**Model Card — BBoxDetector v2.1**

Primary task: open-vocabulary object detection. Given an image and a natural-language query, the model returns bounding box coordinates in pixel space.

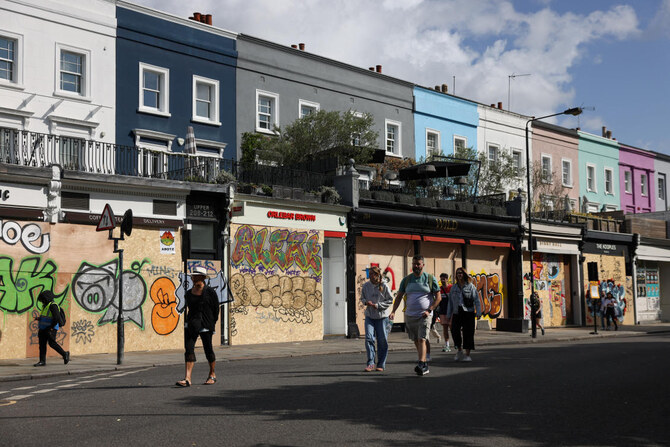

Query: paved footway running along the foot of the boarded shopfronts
[0,323,670,382]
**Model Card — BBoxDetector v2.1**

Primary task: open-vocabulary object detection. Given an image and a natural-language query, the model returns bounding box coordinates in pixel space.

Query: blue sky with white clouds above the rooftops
[131,0,670,154]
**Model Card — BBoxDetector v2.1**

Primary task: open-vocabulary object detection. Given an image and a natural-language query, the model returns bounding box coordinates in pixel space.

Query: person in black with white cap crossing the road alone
[177,267,219,386]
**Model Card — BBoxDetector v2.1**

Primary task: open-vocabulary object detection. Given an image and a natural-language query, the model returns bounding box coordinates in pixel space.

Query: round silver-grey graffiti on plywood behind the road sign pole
[72,259,148,329]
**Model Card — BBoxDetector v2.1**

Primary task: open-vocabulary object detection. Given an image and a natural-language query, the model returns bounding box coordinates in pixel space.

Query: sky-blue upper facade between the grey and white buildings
[414,86,479,160]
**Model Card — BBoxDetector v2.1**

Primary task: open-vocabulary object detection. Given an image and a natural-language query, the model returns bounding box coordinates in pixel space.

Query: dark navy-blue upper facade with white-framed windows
[116,1,237,176]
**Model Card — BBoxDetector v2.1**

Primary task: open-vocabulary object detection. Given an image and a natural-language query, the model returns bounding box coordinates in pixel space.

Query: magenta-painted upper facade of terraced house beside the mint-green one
[619,144,656,213]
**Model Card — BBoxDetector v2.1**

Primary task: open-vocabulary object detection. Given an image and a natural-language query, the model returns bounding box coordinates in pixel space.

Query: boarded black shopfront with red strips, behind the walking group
[350,207,518,330]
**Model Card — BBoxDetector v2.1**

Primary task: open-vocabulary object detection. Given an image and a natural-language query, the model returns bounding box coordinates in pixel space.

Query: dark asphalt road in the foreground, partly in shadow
[0,334,670,447]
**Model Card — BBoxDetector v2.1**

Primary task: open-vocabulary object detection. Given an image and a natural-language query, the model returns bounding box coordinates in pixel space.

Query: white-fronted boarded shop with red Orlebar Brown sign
[229,195,349,345]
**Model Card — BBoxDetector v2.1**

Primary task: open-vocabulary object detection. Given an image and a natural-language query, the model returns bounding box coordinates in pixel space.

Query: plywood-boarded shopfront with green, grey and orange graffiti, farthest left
[0,220,183,359]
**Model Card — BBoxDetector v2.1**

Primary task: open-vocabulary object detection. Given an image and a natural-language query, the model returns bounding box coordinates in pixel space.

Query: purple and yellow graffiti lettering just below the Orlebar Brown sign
[231,225,323,277]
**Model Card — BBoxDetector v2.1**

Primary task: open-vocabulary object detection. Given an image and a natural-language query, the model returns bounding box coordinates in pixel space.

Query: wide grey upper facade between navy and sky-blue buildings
[236,34,414,158]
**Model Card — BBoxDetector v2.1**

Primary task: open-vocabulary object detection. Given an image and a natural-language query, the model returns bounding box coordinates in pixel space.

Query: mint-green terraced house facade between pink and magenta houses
[579,131,621,213]
